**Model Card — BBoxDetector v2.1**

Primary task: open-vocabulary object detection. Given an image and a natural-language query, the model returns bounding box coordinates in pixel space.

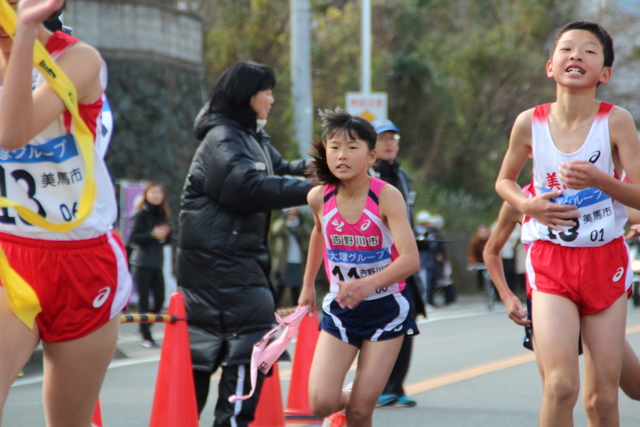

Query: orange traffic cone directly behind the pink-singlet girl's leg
[284,311,322,424]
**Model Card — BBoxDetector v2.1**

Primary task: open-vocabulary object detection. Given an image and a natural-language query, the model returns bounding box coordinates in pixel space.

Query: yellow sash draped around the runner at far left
[0,0,96,329]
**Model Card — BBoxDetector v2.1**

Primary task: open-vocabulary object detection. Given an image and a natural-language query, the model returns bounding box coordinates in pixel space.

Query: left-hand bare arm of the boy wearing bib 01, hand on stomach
[496,110,579,231]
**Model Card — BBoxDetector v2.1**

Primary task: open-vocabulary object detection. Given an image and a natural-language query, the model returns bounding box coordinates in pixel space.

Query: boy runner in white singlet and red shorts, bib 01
[496,21,640,427]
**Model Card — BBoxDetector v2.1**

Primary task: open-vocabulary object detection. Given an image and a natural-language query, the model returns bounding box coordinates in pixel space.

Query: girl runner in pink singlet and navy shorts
[298,110,420,427]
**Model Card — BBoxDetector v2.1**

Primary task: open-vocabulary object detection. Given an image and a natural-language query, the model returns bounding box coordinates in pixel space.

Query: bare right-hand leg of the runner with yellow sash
[42,316,120,427]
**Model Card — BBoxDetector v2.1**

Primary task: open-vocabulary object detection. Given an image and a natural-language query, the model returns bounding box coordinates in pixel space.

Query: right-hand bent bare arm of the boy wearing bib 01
[560,107,640,209]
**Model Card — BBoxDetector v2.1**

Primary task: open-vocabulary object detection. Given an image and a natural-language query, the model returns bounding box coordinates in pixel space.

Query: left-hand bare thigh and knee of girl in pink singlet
[309,331,358,417]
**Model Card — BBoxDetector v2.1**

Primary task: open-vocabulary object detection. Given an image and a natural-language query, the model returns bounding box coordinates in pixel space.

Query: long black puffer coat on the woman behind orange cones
[177,113,311,372]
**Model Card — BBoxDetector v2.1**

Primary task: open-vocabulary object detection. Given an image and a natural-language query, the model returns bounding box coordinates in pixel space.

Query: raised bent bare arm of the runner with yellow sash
[0,0,102,150]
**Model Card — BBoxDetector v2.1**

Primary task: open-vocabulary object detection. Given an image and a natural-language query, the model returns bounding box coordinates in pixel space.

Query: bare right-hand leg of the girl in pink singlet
[347,336,404,427]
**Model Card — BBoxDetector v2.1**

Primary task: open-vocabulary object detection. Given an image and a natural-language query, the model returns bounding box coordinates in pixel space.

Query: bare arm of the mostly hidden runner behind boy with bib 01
[483,202,531,326]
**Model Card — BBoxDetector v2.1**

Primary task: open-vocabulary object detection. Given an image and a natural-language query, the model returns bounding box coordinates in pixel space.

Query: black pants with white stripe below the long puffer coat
[193,365,265,427]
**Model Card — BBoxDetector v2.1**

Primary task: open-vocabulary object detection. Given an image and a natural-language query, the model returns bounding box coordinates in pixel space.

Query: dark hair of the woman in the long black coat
[209,61,276,129]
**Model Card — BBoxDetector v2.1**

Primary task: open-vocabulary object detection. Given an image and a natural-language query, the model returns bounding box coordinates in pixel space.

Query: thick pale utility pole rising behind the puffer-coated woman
[290,0,313,157]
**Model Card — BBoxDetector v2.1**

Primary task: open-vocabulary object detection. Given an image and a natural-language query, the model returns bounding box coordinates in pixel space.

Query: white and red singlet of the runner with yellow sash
[0,31,117,240]
